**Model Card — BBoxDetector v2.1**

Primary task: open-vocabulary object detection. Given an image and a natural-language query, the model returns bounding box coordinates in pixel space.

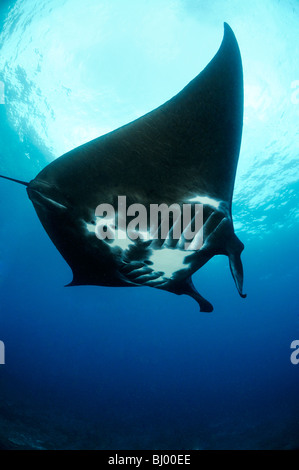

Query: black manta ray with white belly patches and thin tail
[2,23,245,312]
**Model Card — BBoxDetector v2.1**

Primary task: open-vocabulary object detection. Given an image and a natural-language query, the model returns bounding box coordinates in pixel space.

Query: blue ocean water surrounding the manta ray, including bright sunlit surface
[0,0,299,449]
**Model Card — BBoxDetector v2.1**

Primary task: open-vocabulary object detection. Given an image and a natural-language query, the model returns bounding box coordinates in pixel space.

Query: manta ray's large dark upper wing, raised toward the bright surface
[38,24,243,209]
